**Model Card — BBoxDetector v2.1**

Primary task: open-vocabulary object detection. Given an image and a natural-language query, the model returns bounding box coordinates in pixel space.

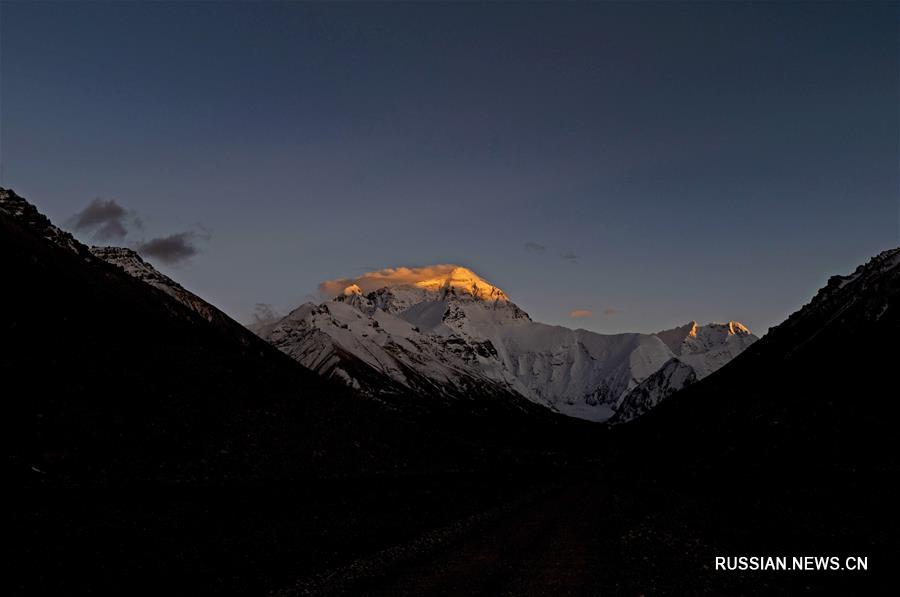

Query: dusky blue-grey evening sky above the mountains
[0,1,900,333]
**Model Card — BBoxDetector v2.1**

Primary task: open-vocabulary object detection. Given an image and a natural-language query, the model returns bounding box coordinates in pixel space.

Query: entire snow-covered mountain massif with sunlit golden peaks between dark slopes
[251,265,756,421]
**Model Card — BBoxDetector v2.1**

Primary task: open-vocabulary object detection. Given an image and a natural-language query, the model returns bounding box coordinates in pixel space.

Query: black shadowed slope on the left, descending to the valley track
[0,190,592,595]
